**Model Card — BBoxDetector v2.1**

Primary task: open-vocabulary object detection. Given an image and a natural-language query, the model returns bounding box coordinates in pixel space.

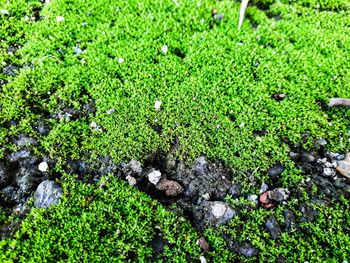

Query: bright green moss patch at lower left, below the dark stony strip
[0,176,199,262]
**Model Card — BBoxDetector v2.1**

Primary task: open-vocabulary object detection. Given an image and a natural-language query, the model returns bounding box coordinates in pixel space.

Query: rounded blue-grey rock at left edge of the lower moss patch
[34,180,62,208]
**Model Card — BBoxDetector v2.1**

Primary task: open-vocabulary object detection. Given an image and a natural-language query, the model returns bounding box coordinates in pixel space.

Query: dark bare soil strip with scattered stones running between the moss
[0,131,350,257]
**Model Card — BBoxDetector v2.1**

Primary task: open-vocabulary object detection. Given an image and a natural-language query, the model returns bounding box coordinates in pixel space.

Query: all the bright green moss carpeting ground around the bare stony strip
[0,0,350,262]
